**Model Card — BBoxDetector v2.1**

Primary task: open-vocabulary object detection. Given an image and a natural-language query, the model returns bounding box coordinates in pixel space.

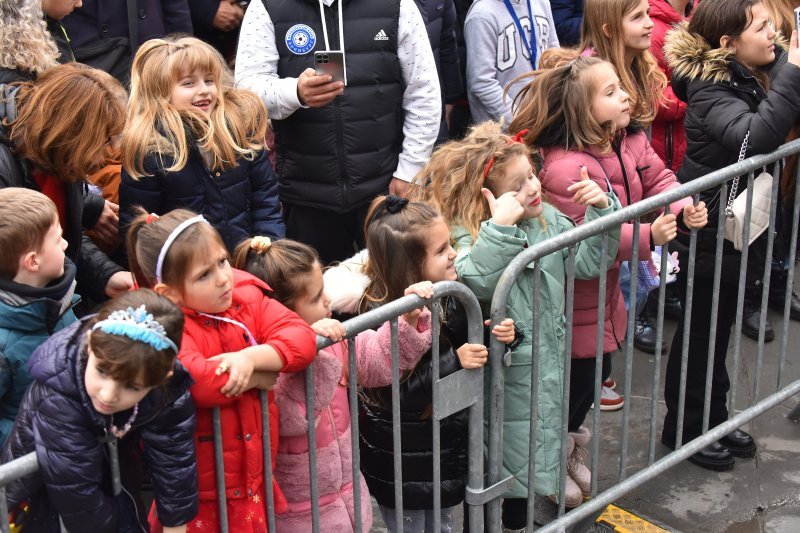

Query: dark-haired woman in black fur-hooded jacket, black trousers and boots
[661,0,800,470]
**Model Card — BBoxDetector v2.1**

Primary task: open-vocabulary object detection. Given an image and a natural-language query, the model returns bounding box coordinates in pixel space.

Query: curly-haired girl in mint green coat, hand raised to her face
[421,122,619,529]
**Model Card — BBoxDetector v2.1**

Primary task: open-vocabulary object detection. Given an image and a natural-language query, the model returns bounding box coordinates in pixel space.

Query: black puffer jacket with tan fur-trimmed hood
[664,23,800,284]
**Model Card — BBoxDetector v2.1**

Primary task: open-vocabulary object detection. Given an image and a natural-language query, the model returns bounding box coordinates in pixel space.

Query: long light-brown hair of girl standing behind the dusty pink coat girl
[540,0,668,127]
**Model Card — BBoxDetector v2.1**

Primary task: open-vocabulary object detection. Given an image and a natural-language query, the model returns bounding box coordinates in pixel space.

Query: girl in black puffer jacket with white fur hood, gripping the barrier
[325,195,514,532]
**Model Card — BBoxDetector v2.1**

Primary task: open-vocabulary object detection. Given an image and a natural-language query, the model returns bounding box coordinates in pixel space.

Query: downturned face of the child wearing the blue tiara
[84,344,153,415]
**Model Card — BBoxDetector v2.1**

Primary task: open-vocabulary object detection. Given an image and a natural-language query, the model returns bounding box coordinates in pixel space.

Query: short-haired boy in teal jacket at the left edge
[0,187,78,446]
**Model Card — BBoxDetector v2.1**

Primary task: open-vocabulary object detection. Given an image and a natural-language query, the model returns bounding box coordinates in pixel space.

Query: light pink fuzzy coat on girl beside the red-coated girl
[275,310,431,533]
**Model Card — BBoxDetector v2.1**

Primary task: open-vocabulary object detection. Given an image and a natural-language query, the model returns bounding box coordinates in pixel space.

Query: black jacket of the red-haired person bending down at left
[0,85,123,301]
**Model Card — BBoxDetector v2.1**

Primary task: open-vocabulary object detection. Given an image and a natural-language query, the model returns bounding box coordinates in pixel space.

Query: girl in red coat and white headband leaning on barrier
[128,209,316,533]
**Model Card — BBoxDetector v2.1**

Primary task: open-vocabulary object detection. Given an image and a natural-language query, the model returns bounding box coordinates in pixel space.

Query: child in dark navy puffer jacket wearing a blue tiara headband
[3,289,198,533]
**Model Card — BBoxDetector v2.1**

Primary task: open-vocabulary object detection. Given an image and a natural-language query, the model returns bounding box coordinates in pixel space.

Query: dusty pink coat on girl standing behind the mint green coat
[539,131,692,359]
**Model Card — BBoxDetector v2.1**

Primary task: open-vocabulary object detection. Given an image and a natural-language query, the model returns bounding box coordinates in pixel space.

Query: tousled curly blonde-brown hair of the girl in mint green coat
[412,120,530,239]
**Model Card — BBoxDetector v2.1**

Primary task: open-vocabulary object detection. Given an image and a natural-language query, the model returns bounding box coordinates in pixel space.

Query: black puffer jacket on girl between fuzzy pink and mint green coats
[358,298,468,509]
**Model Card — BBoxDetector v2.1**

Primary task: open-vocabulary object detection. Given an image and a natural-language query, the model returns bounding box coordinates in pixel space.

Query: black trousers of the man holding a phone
[283,202,369,265]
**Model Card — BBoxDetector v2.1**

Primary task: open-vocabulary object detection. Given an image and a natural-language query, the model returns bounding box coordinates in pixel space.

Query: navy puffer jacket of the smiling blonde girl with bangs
[119,143,286,252]
